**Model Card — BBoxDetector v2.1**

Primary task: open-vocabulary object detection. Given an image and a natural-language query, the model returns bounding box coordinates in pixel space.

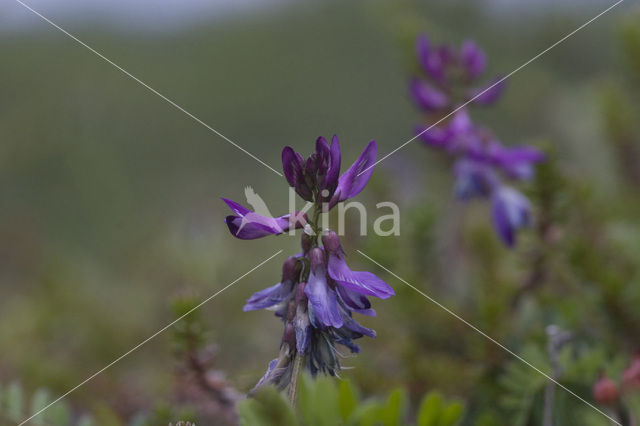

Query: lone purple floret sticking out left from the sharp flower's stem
[222,198,306,240]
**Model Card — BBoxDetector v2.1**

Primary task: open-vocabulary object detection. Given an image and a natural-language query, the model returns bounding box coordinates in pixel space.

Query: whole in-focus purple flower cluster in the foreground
[223,136,394,389]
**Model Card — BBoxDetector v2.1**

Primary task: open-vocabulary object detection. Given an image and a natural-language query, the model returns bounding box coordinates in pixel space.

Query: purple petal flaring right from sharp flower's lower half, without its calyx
[329,253,395,299]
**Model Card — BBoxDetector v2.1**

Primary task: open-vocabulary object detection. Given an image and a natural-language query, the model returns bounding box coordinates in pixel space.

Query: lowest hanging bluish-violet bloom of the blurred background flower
[491,186,531,247]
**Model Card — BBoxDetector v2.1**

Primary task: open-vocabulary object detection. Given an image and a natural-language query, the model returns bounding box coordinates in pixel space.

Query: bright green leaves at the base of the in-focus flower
[238,376,463,426]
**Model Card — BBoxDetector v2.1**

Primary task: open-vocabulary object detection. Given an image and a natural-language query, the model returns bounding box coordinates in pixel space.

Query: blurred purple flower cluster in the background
[409,36,544,247]
